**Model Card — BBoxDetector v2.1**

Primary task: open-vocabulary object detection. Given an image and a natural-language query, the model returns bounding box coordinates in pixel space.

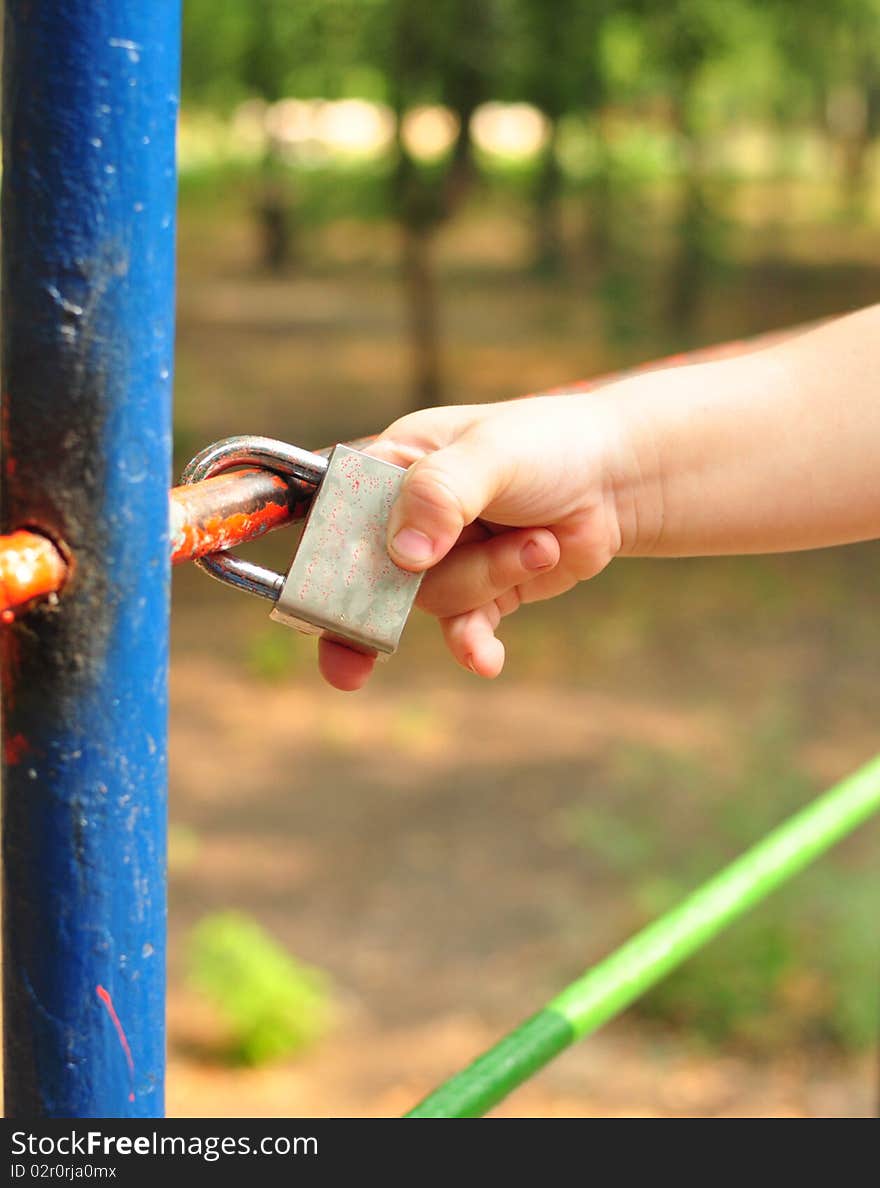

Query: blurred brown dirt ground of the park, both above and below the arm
[162,194,880,1116]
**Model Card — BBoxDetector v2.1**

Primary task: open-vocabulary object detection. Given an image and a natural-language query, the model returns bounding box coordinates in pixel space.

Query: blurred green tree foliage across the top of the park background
[176,0,880,311]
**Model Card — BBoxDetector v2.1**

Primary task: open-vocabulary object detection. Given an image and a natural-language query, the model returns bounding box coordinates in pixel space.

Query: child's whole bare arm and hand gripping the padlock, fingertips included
[319,305,880,690]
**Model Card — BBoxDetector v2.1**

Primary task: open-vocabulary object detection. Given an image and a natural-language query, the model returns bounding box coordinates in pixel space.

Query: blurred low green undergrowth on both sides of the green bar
[561,709,880,1051]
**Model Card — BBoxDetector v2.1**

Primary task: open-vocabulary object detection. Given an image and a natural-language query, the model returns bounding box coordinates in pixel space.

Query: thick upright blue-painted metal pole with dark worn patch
[0,0,179,1118]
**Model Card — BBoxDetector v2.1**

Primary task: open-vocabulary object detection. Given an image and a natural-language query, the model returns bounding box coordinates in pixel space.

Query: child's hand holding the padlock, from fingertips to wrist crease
[319,394,621,689]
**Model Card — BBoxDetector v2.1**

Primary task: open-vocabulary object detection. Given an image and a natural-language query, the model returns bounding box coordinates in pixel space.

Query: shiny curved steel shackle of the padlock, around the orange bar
[181,435,328,602]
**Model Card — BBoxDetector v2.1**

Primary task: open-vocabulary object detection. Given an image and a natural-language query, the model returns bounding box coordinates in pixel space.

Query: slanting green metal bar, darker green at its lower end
[407,756,880,1118]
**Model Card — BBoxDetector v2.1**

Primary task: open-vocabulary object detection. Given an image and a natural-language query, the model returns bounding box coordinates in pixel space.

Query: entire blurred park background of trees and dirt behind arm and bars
[169,0,880,1116]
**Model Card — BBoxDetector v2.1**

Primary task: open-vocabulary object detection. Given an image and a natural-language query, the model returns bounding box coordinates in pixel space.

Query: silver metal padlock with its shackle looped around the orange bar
[182,437,422,658]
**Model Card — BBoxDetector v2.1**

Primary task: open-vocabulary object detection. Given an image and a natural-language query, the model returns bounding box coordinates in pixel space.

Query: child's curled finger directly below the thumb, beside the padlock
[418,529,559,619]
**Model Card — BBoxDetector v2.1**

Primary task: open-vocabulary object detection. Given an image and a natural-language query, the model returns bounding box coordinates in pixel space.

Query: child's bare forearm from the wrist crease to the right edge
[600,307,880,556]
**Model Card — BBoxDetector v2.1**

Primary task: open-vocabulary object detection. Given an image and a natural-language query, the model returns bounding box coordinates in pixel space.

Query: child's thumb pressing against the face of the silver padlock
[388,432,507,570]
